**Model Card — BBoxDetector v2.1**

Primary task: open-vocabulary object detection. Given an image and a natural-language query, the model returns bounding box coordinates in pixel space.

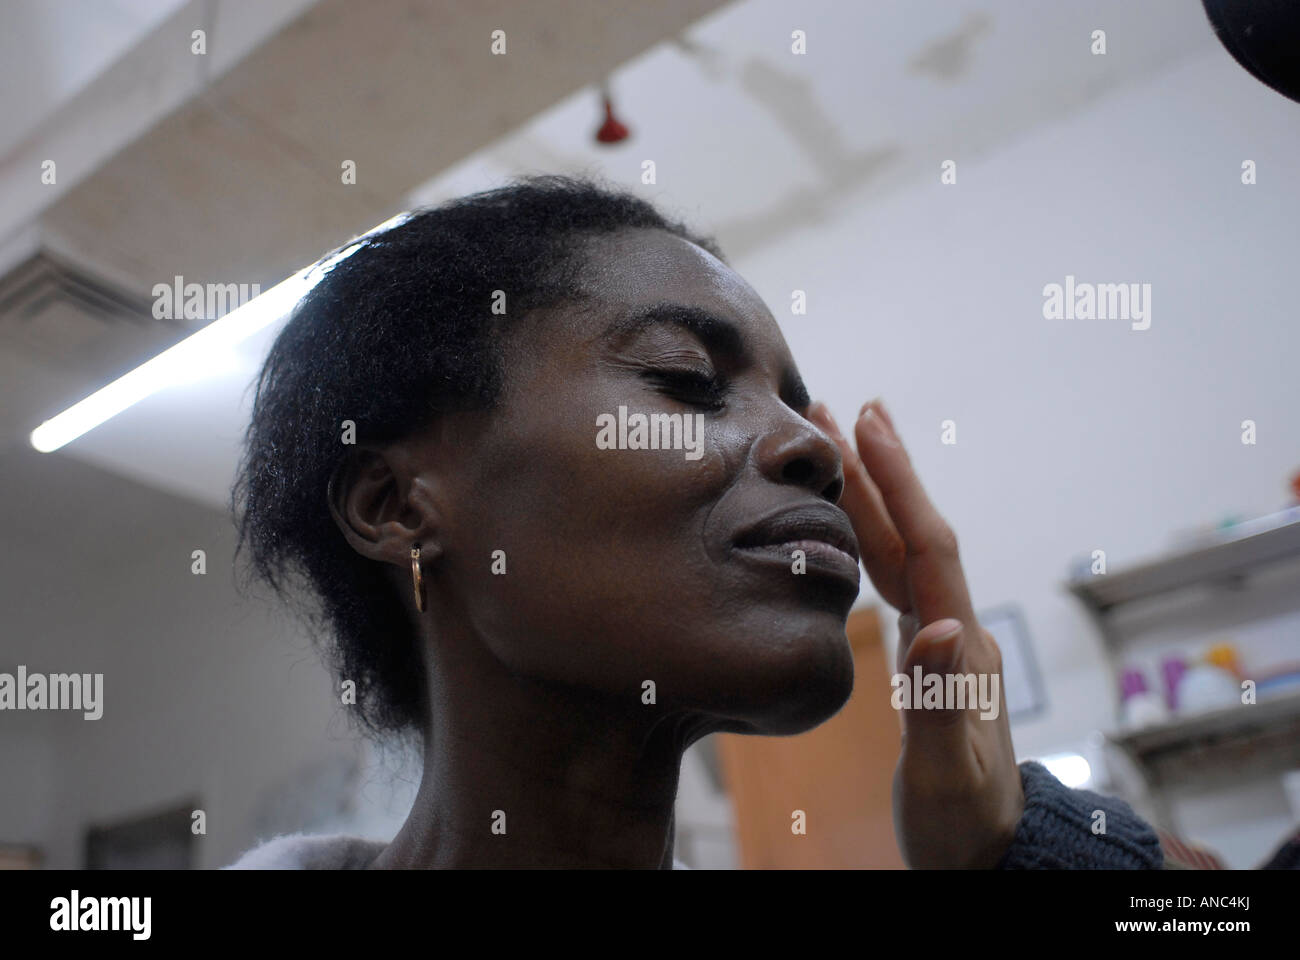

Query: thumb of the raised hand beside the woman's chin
[893,619,966,762]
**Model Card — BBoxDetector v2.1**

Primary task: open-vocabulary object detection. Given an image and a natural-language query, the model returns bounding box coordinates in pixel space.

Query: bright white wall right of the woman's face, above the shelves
[738,44,1300,866]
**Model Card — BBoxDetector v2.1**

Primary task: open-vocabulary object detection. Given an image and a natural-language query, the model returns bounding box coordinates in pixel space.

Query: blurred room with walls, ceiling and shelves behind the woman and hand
[0,0,1300,869]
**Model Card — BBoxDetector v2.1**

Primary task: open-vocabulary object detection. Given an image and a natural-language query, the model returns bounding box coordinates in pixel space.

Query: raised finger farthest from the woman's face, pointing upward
[854,401,975,624]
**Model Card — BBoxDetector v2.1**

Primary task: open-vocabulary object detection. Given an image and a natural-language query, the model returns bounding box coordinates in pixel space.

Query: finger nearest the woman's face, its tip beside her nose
[809,403,910,610]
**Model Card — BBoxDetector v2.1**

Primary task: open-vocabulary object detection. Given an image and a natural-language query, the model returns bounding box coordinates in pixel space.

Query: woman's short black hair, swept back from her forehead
[231,176,720,738]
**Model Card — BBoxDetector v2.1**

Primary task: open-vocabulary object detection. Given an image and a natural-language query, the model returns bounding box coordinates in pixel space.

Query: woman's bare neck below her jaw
[373,613,707,869]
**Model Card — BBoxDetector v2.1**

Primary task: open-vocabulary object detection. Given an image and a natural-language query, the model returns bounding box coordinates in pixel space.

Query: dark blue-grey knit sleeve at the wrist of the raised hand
[997,760,1164,870]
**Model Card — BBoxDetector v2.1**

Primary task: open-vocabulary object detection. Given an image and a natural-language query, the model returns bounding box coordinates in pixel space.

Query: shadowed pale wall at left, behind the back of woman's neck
[0,454,412,868]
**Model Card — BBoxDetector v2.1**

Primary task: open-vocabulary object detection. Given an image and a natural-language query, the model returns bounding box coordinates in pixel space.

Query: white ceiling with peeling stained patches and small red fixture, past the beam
[17,0,1217,506]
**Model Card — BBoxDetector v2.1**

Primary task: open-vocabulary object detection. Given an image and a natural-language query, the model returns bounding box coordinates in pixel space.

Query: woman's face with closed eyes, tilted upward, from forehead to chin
[421,230,858,734]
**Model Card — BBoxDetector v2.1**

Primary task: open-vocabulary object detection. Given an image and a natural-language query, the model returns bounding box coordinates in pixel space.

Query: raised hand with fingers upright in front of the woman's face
[809,401,1024,868]
